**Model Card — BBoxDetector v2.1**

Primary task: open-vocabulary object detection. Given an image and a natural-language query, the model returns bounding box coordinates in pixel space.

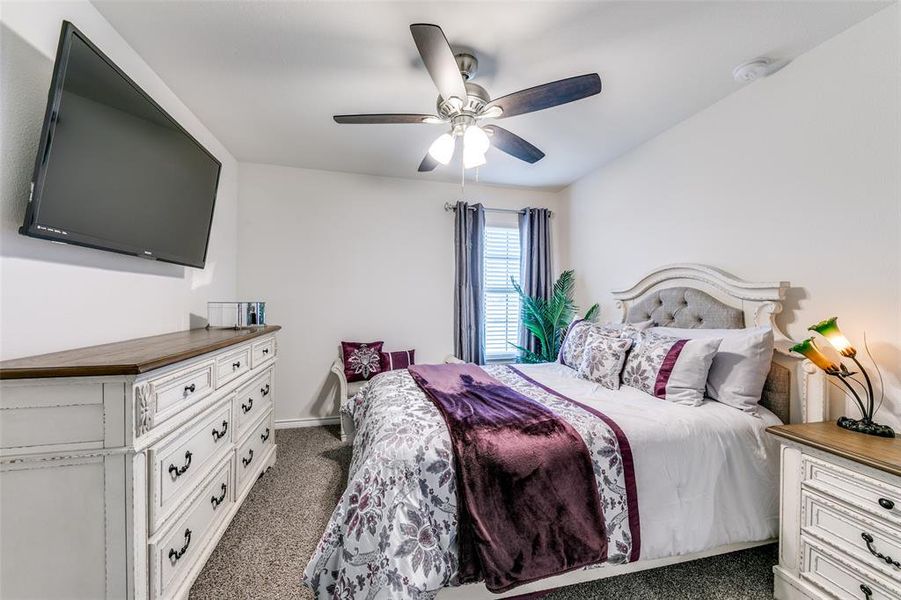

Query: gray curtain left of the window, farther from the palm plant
[454,202,485,365]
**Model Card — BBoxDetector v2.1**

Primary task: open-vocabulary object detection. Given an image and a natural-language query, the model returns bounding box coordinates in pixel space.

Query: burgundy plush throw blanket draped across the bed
[409,364,607,592]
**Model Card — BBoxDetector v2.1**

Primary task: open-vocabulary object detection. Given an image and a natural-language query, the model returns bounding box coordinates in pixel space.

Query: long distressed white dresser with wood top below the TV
[0,326,279,600]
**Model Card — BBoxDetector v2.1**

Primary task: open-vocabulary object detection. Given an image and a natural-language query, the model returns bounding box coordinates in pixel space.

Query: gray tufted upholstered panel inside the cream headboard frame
[625,278,791,423]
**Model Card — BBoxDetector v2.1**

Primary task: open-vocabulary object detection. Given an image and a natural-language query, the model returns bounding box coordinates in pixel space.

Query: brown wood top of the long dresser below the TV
[0,325,281,379]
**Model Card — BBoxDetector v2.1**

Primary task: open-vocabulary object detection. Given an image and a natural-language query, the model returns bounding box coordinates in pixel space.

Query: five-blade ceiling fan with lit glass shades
[334,23,601,172]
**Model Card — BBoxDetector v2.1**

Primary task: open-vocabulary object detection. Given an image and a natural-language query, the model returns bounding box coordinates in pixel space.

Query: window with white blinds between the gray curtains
[484,225,520,361]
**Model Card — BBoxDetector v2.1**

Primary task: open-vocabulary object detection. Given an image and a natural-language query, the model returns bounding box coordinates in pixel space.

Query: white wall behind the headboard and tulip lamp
[561,5,901,426]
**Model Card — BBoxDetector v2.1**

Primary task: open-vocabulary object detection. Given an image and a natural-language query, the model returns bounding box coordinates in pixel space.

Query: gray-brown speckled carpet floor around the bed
[190,427,777,600]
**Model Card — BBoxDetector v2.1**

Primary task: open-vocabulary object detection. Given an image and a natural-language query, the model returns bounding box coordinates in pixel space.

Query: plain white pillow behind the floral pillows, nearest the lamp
[648,326,773,414]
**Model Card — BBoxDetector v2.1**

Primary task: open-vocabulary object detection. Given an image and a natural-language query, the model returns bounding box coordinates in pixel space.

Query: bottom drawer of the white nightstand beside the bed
[801,540,901,600]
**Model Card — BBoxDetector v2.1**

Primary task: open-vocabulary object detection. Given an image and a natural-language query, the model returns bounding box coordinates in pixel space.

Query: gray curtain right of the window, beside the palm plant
[519,208,554,352]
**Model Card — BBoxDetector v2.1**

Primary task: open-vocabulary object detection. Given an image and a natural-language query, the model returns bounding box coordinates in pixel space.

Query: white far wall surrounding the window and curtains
[238,163,560,421]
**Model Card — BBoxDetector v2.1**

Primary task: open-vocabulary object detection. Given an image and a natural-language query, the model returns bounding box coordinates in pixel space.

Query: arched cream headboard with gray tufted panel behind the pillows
[613,264,826,423]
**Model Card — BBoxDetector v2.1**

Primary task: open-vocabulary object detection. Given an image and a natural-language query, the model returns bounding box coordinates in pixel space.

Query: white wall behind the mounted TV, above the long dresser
[0,1,237,359]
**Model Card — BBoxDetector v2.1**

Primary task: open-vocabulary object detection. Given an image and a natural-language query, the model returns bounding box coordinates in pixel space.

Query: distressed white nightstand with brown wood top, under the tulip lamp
[767,423,901,600]
